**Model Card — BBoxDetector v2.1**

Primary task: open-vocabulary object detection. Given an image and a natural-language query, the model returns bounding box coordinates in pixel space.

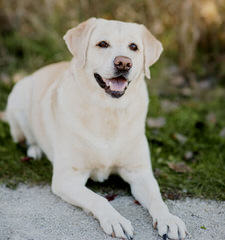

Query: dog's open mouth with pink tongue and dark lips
[94,73,129,98]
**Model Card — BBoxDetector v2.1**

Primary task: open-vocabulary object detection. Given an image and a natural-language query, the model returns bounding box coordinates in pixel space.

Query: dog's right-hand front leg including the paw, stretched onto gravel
[120,167,186,240]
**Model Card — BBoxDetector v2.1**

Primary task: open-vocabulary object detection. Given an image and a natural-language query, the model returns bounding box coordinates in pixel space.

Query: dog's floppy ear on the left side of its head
[63,18,96,68]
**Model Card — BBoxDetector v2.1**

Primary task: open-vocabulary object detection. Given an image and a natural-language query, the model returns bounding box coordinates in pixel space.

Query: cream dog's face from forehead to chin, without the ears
[87,20,144,98]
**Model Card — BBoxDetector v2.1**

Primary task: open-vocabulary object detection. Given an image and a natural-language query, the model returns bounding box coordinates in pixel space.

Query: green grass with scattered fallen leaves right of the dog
[147,94,225,200]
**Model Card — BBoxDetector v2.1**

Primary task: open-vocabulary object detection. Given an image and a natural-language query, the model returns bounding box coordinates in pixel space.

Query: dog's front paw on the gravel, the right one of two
[153,214,187,240]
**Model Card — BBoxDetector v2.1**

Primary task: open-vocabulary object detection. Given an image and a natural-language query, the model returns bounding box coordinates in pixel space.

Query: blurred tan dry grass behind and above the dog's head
[0,0,225,75]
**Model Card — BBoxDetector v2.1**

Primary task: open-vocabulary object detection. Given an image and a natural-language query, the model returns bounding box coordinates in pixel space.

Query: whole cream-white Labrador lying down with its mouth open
[5,18,186,239]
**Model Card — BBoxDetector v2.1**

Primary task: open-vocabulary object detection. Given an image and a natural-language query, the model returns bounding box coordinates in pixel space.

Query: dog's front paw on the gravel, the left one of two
[100,214,134,240]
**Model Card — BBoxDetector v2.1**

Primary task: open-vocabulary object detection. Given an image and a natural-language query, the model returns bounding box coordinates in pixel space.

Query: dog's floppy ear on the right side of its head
[142,25,163,79]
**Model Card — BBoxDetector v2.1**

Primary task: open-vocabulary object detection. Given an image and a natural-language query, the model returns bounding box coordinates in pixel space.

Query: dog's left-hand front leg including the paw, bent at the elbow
[52,165,133,240]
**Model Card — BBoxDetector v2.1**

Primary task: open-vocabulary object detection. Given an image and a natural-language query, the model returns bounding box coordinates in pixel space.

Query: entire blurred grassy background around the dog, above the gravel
[0,0,225,199]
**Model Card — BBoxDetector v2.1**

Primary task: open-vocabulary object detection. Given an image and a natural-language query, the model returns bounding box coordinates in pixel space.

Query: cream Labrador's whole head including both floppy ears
[64,18,163,98]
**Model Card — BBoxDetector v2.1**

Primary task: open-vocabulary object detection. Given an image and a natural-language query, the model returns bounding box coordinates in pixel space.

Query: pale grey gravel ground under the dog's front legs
[0,185,225,240]
